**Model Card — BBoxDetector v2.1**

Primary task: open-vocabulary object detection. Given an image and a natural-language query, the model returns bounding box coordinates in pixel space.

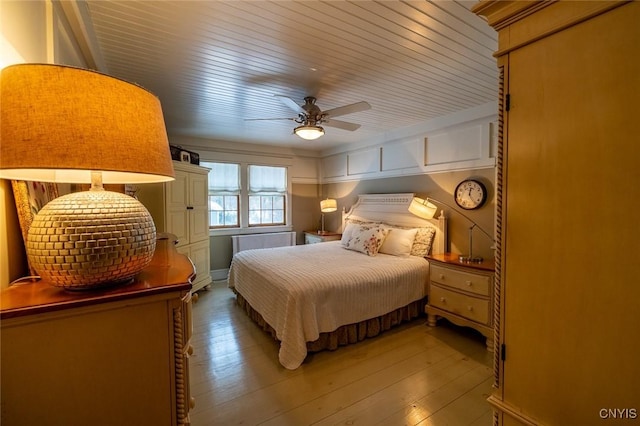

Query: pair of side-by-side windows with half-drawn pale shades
[202,162,288,229]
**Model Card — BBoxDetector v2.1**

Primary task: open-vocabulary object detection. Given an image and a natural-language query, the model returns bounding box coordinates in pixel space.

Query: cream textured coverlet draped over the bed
[229,241,429,369]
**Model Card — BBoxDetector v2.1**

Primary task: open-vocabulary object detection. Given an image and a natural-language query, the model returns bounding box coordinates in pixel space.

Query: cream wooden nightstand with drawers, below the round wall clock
[425,253,495,351]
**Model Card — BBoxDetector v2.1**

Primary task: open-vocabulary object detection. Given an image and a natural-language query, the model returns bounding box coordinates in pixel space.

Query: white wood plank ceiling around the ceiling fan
[86,0,497,149]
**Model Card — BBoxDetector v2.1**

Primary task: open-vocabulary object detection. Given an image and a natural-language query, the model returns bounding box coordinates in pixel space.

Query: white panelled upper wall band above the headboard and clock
[320,102,498,183]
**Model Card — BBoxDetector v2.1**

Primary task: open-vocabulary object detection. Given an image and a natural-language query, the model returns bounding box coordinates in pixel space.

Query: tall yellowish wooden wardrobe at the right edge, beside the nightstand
[473,1,640,426]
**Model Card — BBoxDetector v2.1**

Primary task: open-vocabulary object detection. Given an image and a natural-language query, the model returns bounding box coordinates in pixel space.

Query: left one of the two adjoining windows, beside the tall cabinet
[208,163,240,228]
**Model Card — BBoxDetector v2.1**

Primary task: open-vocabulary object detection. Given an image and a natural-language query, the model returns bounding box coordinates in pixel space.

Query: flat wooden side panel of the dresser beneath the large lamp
[0,298,175,426]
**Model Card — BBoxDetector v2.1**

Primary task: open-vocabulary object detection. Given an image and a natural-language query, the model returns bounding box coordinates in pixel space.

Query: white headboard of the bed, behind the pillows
[342,193,447,254]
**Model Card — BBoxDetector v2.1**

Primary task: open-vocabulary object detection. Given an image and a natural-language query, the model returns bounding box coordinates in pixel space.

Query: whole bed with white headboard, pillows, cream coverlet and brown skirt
[229,193,446,370]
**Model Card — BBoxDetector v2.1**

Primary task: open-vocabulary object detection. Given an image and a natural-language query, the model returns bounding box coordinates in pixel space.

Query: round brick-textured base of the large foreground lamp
[27,190,156,290]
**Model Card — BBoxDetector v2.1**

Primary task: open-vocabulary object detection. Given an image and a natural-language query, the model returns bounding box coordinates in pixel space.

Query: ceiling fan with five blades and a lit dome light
[248,95,371,140]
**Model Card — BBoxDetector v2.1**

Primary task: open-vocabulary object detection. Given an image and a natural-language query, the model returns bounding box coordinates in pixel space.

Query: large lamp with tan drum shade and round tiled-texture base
[0,64,174,290]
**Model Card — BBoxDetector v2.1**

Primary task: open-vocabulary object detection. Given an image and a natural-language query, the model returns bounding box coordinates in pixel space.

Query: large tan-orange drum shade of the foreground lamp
[0,64,174,184]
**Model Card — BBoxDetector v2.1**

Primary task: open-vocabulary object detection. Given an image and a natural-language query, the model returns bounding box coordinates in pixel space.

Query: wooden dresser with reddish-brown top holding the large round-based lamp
[0,239,194,426]
